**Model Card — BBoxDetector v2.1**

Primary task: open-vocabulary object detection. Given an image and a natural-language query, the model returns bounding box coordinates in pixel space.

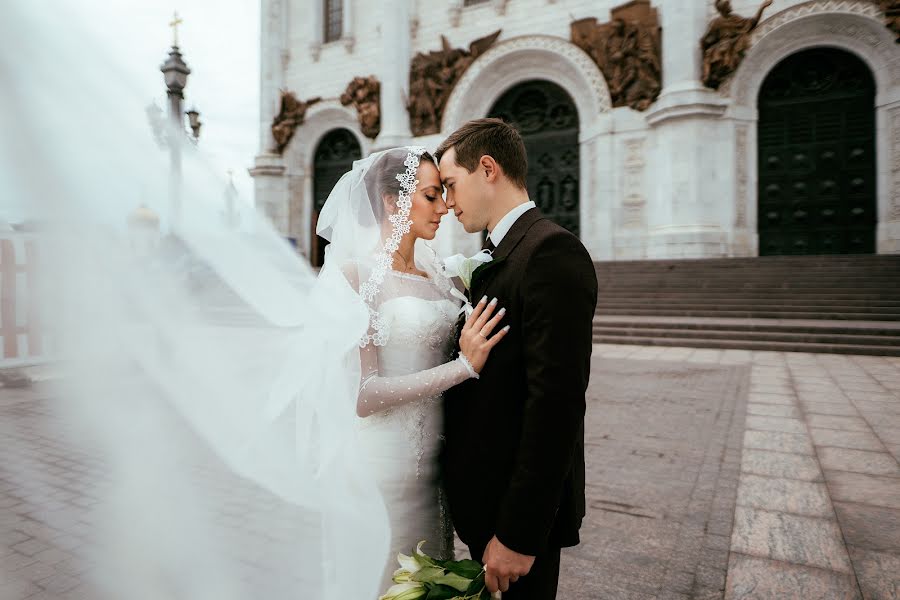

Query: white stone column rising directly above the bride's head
[373,0,412,150]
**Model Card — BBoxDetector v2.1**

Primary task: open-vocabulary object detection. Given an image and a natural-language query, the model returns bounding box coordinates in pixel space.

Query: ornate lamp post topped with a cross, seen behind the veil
[159,12,202,229]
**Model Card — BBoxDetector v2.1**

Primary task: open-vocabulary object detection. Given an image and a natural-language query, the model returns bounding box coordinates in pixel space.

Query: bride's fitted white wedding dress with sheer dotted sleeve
[358,271,470,590]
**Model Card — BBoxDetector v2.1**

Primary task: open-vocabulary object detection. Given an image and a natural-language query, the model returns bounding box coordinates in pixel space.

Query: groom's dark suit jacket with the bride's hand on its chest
[442,208,597,559]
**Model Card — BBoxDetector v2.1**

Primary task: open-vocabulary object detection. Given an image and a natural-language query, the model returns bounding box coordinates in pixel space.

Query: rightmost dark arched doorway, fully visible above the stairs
[757,48,877,255]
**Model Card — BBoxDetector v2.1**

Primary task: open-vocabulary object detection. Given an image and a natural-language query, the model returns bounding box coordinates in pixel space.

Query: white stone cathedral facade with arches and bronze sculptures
[251,0,900,264]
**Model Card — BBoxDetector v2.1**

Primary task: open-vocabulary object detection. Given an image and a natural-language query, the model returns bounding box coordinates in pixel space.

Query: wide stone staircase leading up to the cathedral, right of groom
[594,255,900,356]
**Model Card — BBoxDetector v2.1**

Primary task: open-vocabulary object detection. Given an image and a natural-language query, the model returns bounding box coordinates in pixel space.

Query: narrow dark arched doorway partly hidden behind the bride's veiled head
[309,129,362,267]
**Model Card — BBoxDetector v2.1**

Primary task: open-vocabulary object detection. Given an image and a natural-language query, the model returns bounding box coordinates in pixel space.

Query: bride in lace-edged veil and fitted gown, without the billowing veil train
[318,148,506,589]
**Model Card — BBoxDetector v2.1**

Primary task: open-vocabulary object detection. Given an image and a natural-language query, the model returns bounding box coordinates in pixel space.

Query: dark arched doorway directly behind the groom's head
[489,81,580,235]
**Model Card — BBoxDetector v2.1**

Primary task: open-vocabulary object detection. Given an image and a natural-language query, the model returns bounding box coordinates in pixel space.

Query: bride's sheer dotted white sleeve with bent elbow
[356,344,478,417]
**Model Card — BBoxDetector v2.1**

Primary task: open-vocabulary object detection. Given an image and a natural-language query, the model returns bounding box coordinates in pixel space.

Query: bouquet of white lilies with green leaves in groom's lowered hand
[378,542,491,600]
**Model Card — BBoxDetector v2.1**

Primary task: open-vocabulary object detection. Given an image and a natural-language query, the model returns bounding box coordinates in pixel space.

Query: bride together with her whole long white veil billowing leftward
[0,1,505,600]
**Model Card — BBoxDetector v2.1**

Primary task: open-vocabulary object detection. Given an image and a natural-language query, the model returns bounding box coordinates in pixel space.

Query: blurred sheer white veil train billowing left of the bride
[0,0,388,600]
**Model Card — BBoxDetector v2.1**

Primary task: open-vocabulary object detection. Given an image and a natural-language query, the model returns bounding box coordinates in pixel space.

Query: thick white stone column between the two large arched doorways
[646,2,734,258]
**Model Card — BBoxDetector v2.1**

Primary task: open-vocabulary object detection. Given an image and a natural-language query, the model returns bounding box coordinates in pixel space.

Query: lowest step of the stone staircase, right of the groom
[594,335,900,356]
